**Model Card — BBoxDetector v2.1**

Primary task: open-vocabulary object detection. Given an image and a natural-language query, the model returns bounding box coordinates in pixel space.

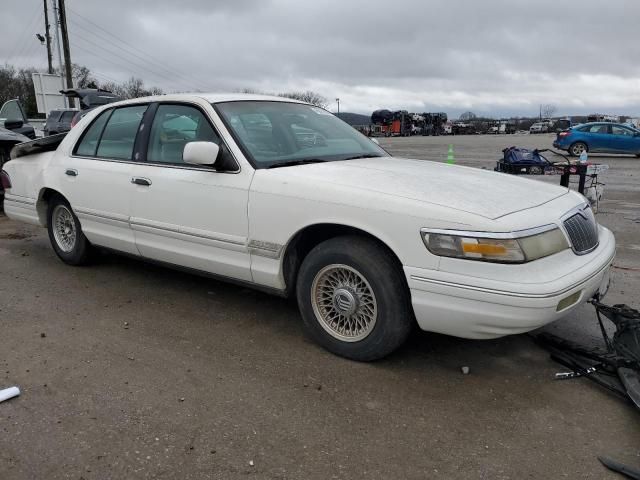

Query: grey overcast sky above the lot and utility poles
[0,0,640,117]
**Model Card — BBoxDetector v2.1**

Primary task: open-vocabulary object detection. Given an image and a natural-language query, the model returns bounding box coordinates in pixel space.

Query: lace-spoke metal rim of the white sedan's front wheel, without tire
[311,264,378,342]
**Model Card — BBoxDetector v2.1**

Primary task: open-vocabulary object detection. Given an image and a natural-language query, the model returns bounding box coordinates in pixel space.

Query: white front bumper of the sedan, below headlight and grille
[404,227,615,339]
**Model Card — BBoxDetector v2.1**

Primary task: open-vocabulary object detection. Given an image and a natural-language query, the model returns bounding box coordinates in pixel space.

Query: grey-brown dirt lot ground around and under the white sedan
[0,135,640,480]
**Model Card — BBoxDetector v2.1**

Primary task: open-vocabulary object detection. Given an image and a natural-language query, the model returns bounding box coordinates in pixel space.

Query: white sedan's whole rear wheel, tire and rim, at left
[47,195,92,265]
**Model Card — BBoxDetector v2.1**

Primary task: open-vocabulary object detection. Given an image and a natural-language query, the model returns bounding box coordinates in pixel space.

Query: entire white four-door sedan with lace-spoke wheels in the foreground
[1,94,615,360]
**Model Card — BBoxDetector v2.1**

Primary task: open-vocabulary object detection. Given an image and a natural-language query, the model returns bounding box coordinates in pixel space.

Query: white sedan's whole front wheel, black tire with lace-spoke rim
[296,236,414,361]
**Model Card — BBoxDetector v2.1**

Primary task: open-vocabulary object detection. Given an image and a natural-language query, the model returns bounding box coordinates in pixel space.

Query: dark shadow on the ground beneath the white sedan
[95,248,564,375]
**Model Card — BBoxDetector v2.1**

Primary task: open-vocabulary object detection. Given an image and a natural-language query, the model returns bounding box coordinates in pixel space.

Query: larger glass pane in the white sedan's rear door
[96,105,147,160]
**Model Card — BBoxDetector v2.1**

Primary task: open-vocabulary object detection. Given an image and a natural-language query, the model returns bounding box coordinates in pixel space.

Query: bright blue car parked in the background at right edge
[553,122,640,157]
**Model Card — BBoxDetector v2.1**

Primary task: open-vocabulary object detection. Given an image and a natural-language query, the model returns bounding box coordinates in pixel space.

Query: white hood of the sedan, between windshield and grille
[270,157,568,219]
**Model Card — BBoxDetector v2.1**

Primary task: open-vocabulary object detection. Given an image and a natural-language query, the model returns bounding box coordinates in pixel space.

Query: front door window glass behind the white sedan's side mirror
[147,105,220,164]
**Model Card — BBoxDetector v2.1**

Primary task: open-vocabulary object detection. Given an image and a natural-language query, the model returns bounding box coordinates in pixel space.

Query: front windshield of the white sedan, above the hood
[214,101,388,168]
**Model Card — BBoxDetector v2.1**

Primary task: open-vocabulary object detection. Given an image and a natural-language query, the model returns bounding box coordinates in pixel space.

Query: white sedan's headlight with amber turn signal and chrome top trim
[422,226,569,263]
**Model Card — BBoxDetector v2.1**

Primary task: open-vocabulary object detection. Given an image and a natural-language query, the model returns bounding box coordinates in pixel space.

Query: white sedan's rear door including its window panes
[59,104,148,254]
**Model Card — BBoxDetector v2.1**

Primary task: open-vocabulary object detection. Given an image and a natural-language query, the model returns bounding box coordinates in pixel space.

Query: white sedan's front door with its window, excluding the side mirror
[131,103,253,281]
